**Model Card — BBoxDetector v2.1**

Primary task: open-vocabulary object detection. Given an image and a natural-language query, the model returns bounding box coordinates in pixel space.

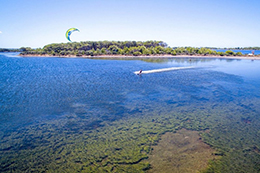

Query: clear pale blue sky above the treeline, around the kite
[0,0,260,48]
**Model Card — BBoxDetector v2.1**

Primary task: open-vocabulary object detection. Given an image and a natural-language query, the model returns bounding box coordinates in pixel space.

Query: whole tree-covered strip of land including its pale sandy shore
[20,40,260,59]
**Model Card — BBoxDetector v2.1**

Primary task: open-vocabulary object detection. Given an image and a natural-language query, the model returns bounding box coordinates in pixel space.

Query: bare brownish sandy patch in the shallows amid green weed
[148,129,218,173]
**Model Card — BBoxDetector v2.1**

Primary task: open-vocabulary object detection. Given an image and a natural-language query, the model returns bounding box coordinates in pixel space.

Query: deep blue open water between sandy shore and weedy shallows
[0,54,260,172]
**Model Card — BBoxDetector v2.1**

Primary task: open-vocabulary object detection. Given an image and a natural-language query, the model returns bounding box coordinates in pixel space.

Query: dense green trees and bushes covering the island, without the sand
[17,41,246,56]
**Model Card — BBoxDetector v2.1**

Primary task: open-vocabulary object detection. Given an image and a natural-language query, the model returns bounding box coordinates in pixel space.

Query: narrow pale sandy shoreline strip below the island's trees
[19,54,260,60]
